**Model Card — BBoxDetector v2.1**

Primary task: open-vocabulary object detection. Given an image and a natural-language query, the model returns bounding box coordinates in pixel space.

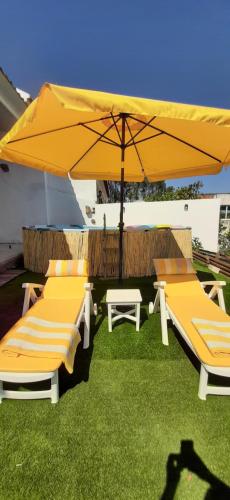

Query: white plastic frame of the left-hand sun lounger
[0,283,97,403]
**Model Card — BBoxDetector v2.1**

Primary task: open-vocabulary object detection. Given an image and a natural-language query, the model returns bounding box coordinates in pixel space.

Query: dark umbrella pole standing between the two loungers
[119,113,126,281]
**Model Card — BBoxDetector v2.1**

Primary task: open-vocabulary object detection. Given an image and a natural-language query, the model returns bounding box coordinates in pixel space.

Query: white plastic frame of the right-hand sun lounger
[152,281,230,400]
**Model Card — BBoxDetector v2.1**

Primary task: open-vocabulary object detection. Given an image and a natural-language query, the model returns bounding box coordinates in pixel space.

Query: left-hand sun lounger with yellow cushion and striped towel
[0,261,96,403]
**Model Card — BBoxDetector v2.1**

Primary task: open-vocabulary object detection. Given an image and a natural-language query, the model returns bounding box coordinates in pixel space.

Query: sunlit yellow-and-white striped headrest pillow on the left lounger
[46,259,88,276]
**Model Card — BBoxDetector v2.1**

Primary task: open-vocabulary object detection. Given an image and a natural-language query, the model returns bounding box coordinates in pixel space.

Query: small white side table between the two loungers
[106,289,142,332]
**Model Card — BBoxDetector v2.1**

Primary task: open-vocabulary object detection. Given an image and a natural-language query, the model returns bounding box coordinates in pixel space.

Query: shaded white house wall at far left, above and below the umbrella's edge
[0,70,47,243]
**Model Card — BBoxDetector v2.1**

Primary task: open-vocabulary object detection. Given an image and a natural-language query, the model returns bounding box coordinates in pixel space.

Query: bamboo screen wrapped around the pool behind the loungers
[23,229,192,278]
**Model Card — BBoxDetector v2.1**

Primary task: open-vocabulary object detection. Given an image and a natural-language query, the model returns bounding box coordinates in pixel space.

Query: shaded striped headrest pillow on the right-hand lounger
[153,258,196,275]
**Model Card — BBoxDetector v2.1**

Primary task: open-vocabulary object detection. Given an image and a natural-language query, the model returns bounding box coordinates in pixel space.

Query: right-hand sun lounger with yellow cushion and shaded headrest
[150,259,230,399]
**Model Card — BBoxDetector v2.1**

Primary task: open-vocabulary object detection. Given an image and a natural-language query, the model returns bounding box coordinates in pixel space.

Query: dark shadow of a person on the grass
[160,440,230,500]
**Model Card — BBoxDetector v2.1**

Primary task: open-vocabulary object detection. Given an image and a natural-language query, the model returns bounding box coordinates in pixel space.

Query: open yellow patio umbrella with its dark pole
[0,83,230,277]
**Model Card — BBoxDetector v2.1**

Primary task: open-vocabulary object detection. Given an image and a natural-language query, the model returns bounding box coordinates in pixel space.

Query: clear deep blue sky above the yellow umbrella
[0,0,230,192]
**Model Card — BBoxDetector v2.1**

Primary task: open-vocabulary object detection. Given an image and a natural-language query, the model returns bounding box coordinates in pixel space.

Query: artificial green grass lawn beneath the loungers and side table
[0,265,230,500]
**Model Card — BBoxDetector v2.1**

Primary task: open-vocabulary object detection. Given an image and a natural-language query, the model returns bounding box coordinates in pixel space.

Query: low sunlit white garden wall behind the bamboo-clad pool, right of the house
[95,199,220,252]
